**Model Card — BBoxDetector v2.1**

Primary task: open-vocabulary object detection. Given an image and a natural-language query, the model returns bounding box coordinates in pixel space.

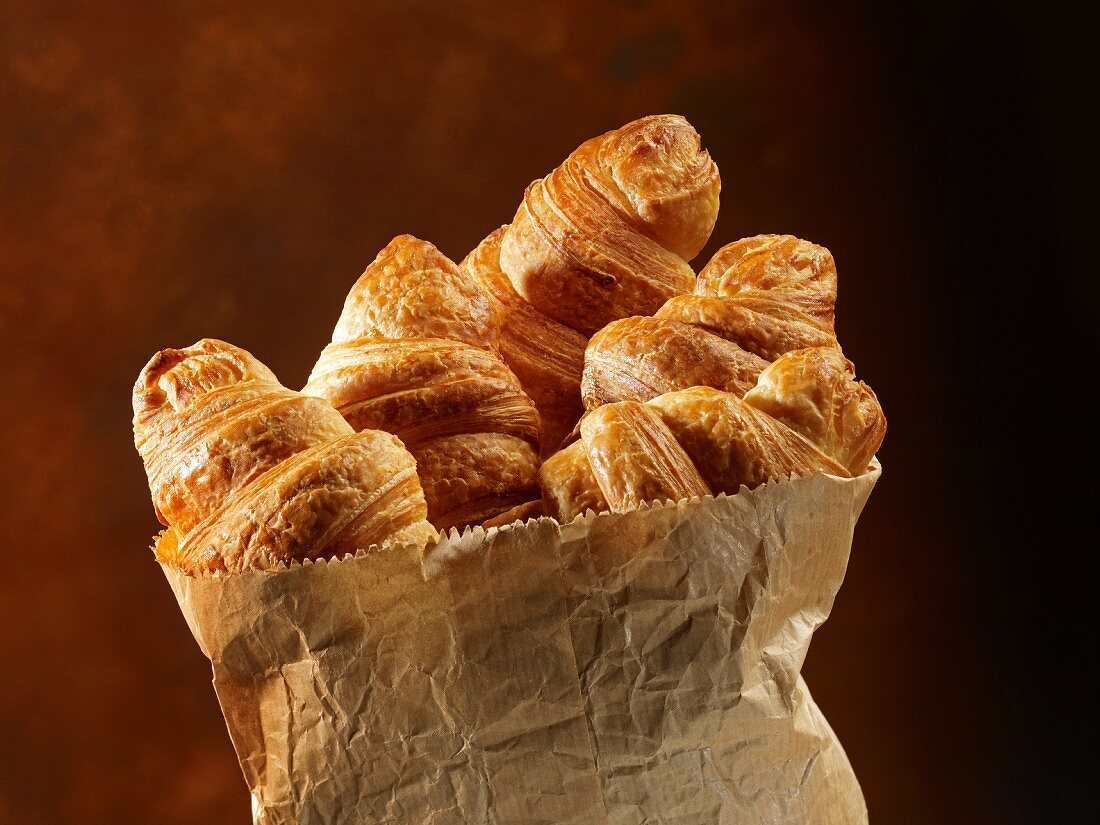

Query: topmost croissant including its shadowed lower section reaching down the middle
[462,116,721,448]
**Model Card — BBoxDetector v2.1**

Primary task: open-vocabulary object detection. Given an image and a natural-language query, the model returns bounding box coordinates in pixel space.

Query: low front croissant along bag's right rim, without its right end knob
[539,387,849,523]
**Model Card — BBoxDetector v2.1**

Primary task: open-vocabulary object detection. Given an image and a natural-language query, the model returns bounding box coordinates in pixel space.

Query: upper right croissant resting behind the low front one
[581,235,839,409]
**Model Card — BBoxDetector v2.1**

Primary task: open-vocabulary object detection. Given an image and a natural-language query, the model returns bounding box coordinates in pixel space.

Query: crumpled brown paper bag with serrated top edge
[165,465,880,825]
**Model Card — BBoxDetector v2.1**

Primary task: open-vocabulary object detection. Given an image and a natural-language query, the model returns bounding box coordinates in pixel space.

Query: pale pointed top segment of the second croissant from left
[332,235,501,347]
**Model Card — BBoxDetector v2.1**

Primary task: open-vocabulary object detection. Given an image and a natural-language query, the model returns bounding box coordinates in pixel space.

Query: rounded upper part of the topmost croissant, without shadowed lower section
[499,114,722,334]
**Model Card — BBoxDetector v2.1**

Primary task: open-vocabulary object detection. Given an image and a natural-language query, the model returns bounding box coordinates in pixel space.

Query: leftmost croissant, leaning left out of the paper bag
[133,339,435,575]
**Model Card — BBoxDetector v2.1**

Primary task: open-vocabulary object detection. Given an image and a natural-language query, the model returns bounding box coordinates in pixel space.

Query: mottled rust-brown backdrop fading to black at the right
[0,0,1097,825]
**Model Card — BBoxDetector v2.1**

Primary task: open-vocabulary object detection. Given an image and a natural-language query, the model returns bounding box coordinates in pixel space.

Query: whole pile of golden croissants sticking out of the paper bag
[133,116,886,575]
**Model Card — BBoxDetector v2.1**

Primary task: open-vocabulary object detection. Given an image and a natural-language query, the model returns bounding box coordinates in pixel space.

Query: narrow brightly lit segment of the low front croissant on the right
[581,402,711,513]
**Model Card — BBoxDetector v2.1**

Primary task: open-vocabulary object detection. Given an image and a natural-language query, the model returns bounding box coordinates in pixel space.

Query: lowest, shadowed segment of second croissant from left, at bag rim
[411,432,539,530]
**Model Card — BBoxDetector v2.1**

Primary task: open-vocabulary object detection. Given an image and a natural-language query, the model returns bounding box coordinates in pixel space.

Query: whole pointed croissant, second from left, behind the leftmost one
[303,235,540,529]
